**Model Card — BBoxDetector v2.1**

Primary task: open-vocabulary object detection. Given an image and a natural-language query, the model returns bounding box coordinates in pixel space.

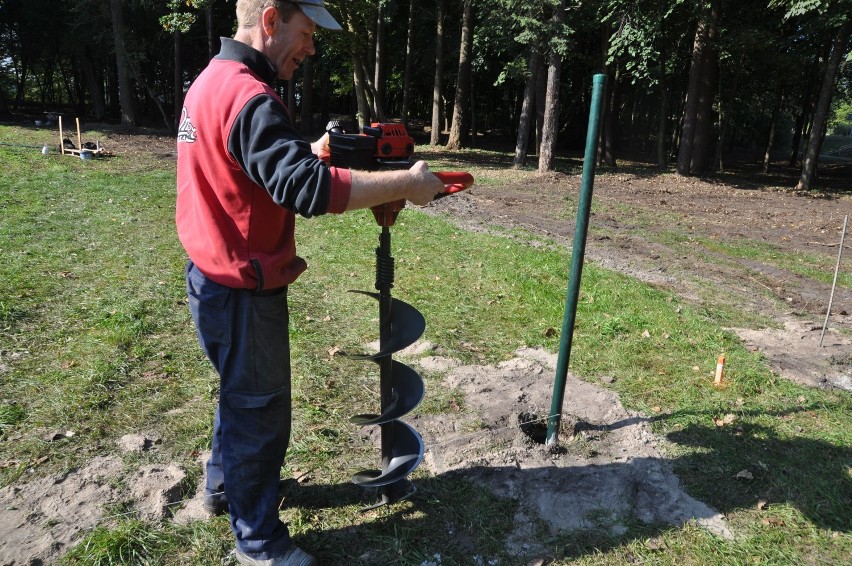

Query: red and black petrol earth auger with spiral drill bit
[326,122,473,509]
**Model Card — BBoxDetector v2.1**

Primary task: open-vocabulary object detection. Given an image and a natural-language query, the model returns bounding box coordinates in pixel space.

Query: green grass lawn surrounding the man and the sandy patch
[0,126,852,565]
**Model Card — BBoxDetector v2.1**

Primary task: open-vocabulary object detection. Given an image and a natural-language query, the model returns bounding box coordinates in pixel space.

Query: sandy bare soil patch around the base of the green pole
[412,348,731,556]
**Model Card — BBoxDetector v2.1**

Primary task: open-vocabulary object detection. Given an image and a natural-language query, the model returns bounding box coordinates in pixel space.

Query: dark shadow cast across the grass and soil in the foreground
[268,407,852,565]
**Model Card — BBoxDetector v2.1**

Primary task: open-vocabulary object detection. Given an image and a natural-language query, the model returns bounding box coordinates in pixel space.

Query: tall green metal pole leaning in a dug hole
[546,75,606,446]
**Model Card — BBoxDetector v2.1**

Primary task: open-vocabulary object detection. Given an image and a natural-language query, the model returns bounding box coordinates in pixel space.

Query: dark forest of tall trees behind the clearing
[0,0,852,189]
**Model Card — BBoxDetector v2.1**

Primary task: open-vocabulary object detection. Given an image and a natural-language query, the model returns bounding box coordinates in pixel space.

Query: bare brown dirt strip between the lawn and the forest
[431,158,852,390]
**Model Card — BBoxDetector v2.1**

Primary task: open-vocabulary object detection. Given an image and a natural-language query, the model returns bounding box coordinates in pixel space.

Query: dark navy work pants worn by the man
[186,261,291,559]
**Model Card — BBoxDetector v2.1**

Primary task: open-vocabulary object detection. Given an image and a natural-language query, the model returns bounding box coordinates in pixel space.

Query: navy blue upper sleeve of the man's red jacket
[228,94,331,218]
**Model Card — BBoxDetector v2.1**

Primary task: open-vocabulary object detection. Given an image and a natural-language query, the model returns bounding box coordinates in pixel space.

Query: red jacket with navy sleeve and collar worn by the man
[175,39,350,290]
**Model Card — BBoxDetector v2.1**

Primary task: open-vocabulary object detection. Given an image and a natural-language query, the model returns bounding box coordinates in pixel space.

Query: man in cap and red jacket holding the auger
[176,0,444,566]
